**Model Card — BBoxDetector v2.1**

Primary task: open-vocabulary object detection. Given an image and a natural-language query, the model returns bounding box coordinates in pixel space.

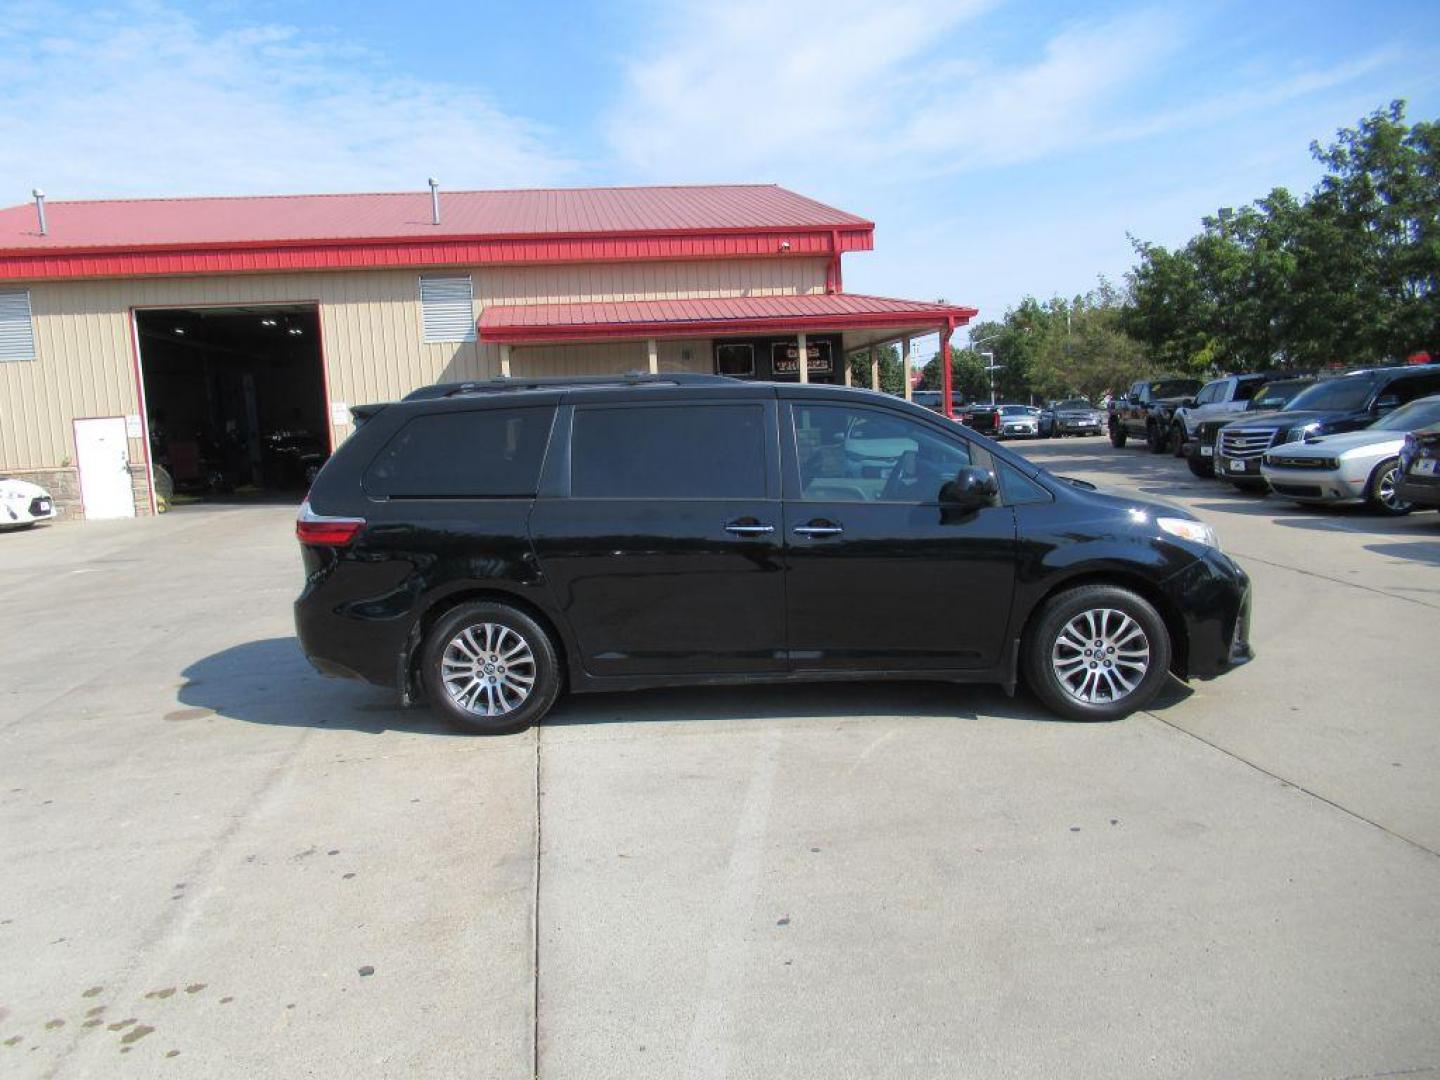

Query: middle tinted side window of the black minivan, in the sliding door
[570,405,765,498]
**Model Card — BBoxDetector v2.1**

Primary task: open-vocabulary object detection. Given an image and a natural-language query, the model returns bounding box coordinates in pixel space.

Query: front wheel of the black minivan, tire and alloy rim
[1022,585,1171,720]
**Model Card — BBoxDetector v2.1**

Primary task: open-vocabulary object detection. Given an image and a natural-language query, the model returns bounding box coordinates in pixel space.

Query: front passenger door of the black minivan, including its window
[782,399,1015,671]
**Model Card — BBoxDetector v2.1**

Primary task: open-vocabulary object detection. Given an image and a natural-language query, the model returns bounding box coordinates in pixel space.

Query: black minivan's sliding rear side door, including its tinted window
[530,392,785,675]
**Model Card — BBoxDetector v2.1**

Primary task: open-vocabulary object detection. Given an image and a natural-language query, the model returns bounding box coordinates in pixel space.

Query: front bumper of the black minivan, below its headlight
[1165,550,1254,680]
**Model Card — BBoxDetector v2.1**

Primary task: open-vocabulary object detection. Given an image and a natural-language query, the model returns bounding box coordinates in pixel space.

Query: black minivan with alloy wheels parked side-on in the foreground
[295,374,1251,732]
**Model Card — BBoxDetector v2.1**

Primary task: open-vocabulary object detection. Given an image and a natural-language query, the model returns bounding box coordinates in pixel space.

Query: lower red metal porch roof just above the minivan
[480,292,976,344]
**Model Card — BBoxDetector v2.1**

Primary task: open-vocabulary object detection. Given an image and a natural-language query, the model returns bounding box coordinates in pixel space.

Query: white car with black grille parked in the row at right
[1260,395,1440,514]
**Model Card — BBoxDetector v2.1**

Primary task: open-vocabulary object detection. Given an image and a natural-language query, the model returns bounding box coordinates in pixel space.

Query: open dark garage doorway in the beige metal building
[135,304,330,505]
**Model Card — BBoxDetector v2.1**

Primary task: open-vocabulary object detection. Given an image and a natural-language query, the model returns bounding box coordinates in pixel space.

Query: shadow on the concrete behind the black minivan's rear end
[177,636,464,736]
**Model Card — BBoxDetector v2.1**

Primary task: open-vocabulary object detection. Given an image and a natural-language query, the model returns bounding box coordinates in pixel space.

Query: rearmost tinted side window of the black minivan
[364,409,554,498]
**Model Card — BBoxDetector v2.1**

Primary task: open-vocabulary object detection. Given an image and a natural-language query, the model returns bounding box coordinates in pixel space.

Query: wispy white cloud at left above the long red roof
[0,3,573,203]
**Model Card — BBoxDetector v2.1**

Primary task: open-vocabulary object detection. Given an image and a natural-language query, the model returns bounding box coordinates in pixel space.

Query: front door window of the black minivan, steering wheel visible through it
[792,405,971,503]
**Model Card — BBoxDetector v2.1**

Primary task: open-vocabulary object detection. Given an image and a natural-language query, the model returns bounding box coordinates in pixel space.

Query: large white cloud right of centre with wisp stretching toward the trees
[608,0,1181,176]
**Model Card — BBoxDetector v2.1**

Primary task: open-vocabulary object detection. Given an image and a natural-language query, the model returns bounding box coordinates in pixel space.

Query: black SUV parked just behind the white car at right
[1215,364,1440,491]
